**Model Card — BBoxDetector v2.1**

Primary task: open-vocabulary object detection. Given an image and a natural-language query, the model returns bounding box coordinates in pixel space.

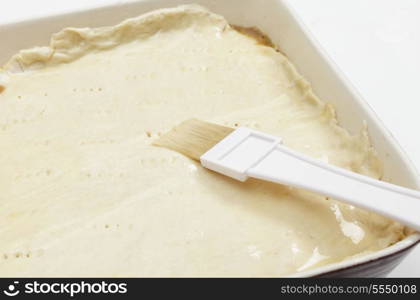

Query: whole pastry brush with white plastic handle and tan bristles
[153,119,420,230]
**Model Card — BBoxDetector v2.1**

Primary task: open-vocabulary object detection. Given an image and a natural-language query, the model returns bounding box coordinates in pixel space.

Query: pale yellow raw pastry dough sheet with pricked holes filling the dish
[0,6,403,276]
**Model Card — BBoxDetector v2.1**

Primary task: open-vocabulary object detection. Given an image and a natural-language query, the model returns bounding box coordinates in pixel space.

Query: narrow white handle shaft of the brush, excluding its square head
[246,146,420,230]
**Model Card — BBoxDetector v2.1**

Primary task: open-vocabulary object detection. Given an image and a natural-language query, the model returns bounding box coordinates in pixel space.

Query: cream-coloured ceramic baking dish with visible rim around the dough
[0,0,420,276]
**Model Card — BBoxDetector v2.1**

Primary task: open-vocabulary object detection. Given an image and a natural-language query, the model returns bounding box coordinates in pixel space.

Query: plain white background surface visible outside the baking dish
[0,0,420,277]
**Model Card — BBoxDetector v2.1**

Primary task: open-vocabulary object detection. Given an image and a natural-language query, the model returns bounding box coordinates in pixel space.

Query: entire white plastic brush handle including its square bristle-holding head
[201,128,420,231]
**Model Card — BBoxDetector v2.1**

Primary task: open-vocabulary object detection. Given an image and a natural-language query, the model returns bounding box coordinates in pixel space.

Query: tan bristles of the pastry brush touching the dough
[153,119,234,161]
